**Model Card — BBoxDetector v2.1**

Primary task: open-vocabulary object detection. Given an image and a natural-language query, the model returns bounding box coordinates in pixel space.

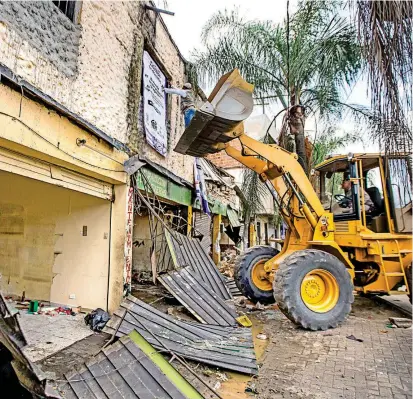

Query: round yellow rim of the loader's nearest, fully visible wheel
[301,269,340,313]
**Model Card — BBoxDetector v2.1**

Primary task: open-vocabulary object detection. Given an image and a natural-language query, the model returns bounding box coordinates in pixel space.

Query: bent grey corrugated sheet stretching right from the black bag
[103,295,258,374]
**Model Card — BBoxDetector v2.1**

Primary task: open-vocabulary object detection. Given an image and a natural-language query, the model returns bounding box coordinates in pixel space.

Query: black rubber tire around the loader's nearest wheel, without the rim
[273,249,354,331]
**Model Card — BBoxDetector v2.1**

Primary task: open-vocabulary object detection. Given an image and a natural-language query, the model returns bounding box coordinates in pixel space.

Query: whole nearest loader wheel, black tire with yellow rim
[274,249,354,330]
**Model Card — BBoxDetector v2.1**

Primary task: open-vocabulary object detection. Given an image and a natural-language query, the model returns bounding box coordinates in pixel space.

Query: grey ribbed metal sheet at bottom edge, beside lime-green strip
[59,337,190,399]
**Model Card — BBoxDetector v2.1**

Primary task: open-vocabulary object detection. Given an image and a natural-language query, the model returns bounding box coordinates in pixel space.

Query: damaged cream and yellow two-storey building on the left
[0,1,237,311]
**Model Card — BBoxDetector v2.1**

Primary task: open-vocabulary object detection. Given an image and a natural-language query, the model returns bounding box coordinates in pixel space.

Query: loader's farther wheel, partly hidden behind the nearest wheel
[234,245,278,304]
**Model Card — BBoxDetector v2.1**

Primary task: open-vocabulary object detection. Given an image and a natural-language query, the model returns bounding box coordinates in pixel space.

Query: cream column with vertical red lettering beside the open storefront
[108,184,133,313]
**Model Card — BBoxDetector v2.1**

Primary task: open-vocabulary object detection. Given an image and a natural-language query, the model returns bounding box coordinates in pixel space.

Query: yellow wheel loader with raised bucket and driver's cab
[175,70,412,330]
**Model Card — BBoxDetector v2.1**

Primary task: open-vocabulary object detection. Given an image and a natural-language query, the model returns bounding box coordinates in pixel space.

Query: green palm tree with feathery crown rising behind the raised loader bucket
[194,1,362,171]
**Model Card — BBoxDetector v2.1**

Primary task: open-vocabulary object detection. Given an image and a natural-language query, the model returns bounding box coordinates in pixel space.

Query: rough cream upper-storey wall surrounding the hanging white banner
[0,1,193,181]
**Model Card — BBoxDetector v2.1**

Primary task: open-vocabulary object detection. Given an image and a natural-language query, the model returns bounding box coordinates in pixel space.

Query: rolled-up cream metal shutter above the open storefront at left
[0,148,113,200]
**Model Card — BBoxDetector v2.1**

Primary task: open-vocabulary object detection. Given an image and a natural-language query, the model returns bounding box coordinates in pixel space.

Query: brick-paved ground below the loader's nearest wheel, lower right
[257,302,412,399]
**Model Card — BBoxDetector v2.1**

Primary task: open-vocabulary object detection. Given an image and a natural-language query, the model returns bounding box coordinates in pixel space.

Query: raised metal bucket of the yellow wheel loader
[174,69,254,157]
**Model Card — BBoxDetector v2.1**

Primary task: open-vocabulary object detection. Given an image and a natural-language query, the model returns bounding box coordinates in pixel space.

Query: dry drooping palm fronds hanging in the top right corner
[350,0,413,152]
